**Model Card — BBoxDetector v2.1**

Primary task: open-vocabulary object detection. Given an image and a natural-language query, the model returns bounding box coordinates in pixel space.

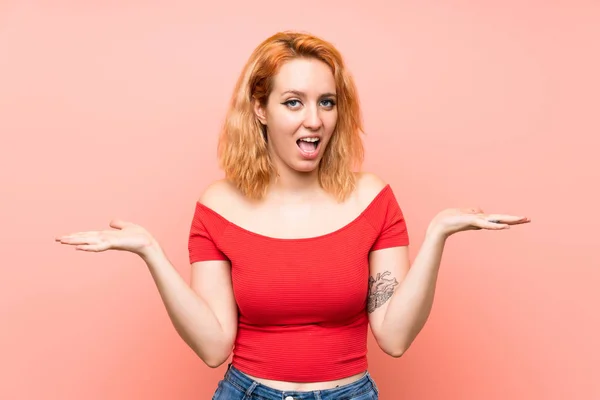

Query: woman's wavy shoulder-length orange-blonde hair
[217,31,364,201]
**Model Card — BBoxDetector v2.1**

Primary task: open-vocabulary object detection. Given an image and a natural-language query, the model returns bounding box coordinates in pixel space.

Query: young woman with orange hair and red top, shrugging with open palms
[57,32,530,400]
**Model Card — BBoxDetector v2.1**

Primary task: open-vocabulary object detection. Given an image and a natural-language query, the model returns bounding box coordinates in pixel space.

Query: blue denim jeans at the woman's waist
[212,364,379,400]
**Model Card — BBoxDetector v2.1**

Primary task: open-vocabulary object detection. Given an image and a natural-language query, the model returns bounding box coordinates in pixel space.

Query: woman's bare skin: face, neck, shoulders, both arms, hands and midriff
[56,55,530,391]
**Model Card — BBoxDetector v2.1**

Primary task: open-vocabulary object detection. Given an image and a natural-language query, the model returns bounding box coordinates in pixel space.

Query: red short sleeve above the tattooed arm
[371,186,410,251]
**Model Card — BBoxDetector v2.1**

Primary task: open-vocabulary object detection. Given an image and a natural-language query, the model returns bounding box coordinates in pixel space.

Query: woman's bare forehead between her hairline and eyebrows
[273,58,335,94]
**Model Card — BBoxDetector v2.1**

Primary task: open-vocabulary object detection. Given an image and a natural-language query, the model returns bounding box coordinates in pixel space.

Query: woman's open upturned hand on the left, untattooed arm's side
[56,219,157,257]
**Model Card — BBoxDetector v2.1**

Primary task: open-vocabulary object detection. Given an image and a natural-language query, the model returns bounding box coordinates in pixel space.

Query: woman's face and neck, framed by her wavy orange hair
[254,59,338,194]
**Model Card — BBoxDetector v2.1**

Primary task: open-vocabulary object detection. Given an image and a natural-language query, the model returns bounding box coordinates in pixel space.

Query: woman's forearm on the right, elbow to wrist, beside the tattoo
[382,232,446,356]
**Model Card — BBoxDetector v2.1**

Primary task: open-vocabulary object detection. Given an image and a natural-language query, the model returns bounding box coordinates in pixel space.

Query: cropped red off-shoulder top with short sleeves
[188,185,409,382]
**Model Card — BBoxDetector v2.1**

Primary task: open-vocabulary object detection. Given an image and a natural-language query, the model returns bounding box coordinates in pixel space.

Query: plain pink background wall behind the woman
[0,0,600,400]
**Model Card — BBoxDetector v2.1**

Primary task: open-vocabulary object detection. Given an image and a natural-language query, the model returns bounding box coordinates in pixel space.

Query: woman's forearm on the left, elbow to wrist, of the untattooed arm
[142,245,231,367]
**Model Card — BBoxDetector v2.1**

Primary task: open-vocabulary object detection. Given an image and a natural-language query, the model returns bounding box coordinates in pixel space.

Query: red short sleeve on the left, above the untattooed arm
[188,203,227,264]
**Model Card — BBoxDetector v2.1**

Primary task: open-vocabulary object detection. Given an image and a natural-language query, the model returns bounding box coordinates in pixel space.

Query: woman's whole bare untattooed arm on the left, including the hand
[56,184,237,368]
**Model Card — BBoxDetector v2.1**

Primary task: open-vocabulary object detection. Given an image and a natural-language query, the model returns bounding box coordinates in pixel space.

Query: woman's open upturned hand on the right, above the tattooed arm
[427,208,531,237]
